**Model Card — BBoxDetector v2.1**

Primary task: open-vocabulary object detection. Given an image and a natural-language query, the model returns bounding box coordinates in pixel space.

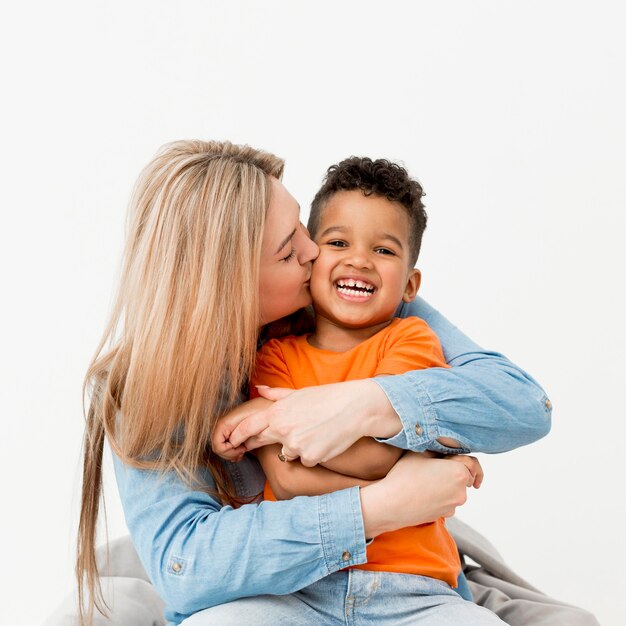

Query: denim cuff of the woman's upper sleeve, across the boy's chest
[373,376,469,454]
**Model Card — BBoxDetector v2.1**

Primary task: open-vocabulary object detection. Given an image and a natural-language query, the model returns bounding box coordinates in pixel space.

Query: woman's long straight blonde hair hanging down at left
[76,141,284,624]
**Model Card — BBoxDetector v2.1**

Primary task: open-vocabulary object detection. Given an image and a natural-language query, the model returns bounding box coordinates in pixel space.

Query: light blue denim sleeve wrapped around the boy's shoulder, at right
[375,297,552,453]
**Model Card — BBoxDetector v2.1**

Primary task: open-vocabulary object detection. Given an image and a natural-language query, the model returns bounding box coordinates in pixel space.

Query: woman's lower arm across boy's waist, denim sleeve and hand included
[114,442,478,623]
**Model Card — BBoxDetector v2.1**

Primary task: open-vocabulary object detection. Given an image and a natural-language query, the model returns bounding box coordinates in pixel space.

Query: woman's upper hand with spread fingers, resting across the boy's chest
[229,380,402,467]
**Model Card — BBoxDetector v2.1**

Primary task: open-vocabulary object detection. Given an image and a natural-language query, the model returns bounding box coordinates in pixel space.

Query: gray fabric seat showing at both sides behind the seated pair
[43,518,599,626]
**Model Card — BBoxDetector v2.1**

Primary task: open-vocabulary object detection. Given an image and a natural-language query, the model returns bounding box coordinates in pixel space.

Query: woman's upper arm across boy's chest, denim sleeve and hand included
[231,298,552,456]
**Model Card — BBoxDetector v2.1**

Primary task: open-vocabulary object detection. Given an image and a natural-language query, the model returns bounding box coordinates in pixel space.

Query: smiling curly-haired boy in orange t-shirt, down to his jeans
[251,157,461,587]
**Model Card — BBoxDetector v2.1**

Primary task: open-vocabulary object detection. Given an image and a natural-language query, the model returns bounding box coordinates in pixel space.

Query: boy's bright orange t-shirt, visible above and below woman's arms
[251,317,461,587]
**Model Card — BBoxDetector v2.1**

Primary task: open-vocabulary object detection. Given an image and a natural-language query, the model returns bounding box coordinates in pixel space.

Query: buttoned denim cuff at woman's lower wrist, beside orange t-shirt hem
[318,487,367,574]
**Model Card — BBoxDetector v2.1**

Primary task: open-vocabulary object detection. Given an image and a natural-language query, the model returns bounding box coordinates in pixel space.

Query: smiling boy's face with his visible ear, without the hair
[311,191,420,328]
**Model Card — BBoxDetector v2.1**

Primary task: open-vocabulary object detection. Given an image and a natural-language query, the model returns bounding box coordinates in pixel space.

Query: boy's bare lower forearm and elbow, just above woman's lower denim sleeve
[256,444,372,500]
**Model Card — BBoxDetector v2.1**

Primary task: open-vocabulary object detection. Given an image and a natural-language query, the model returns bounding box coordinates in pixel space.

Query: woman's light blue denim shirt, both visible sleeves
[114,298,551,624]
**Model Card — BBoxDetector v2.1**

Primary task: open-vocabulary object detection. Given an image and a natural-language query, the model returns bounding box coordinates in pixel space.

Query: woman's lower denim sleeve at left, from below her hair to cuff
[113,454,367,623]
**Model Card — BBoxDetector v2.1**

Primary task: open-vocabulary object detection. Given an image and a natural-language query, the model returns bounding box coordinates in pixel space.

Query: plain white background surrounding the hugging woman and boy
[0,0,626,626]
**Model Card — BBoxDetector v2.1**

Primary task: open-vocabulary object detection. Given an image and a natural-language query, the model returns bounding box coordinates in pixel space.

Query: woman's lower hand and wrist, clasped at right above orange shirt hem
[361,452,483,538]
